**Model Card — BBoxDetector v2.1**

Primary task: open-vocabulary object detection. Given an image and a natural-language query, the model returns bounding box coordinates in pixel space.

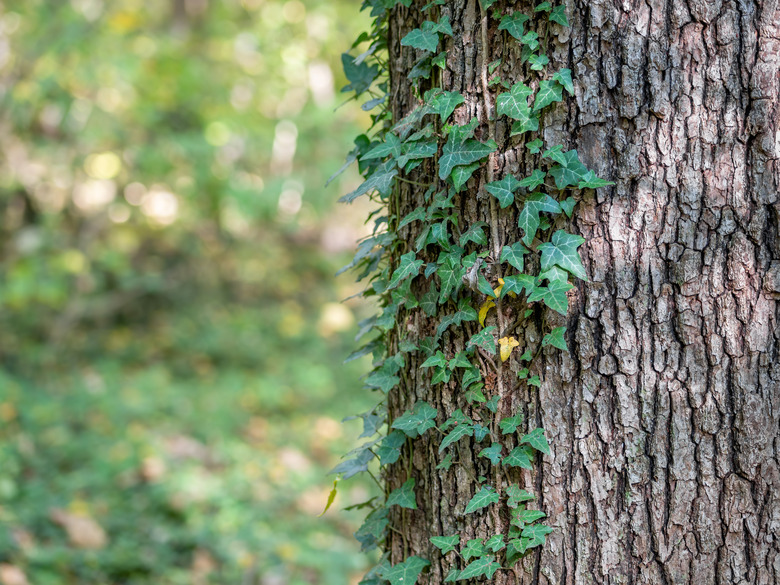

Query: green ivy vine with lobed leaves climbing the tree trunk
[326,0,612,585]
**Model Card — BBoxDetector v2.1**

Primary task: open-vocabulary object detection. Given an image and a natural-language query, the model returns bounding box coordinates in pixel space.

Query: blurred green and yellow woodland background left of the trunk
[0,0,374,585]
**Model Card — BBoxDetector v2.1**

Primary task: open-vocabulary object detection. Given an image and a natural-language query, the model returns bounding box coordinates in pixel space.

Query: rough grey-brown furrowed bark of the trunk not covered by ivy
[388,0,780,585]
